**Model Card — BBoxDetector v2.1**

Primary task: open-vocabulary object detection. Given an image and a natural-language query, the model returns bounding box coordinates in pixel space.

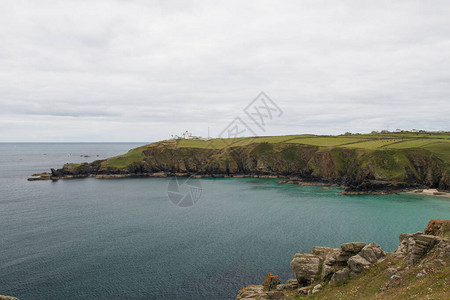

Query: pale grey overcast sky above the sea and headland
[0,0,450,142]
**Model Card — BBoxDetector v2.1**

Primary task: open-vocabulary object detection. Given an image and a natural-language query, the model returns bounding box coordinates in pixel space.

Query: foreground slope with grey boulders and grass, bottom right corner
[236,220,450,299]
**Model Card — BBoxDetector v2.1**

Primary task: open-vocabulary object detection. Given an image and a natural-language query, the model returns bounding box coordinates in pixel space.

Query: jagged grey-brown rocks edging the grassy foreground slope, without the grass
[237,220,450,299]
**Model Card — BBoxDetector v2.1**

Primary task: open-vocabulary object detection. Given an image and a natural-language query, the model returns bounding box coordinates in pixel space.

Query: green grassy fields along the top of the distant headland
[102,133,450,169]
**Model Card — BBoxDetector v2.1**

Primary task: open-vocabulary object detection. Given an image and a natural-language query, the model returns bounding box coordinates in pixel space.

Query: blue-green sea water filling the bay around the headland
[0,144,450,300]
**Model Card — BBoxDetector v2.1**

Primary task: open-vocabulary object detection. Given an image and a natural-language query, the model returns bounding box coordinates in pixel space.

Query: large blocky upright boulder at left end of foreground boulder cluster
[291,254,320,286]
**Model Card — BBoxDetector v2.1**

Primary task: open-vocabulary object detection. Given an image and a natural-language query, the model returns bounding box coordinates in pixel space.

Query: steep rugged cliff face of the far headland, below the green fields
[47,141,450,192]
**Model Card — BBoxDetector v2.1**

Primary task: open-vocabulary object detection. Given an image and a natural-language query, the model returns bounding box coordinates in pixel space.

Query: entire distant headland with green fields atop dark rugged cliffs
[29,135,450,193]
